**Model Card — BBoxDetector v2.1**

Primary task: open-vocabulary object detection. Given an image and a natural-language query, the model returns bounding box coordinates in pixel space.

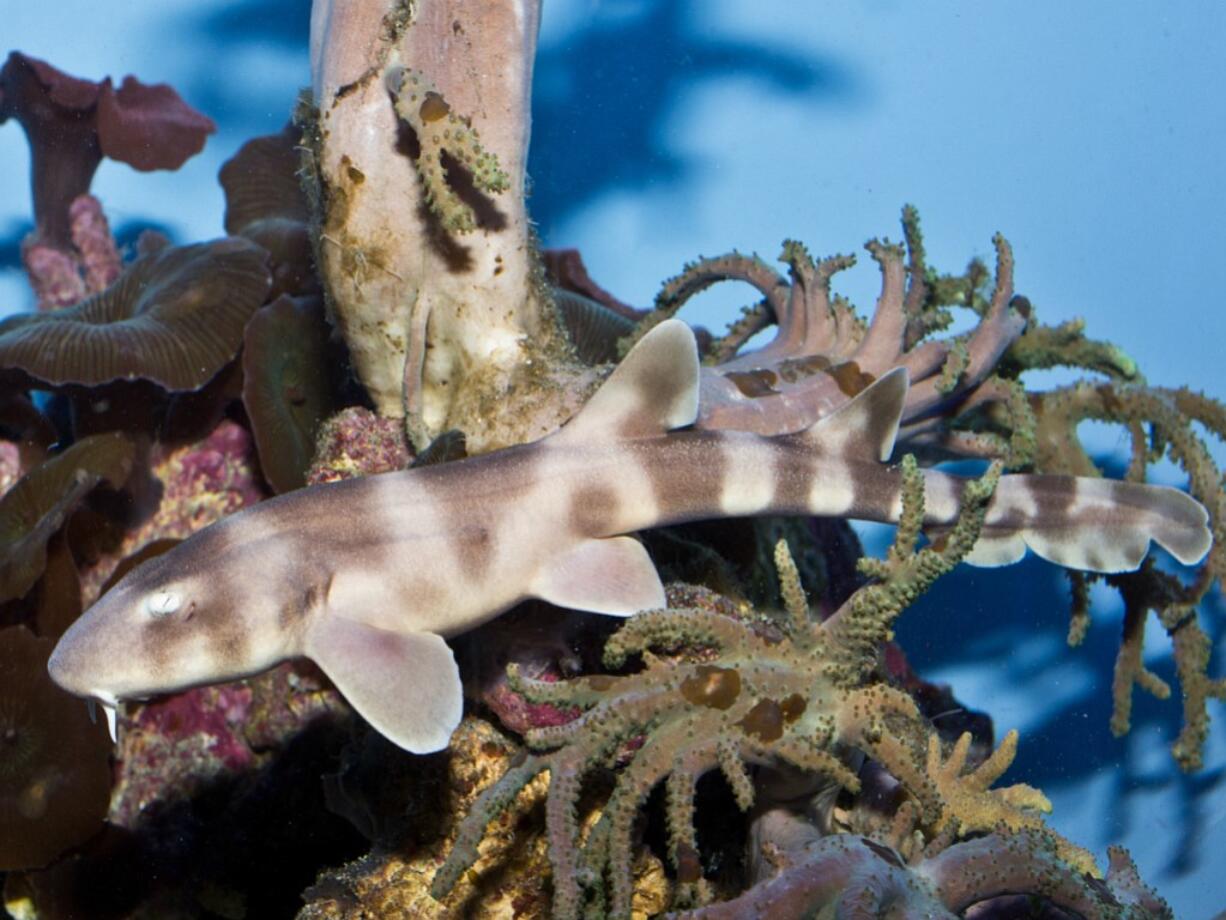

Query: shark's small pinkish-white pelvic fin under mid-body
[530,537,666,617]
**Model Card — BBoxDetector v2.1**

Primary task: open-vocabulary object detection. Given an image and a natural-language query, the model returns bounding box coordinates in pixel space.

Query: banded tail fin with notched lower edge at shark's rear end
[965,475,1213,573]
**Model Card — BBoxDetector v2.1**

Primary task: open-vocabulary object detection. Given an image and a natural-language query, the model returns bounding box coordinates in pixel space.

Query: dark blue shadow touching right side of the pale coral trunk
[528,0,858,237]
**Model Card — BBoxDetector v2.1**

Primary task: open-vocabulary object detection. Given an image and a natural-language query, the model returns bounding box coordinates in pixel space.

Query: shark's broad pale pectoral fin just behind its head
[307,615,463,754]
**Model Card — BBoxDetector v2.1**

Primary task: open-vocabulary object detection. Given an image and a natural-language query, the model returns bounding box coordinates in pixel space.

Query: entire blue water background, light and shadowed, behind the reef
[0,0,1226,920]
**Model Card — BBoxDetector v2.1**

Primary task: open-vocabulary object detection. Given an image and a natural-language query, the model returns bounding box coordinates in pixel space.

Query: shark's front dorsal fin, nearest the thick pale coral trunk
[558,319,699,440]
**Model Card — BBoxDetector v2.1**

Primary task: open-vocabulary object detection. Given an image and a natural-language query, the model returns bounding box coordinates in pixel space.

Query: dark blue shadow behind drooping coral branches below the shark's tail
[897,453,1226,881]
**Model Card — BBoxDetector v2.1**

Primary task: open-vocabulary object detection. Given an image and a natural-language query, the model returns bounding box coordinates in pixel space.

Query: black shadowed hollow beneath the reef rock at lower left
[21,718,369,920]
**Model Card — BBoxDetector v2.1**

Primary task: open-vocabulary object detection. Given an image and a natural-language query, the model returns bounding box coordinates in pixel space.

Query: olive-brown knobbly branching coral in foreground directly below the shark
[433,456,1123,919]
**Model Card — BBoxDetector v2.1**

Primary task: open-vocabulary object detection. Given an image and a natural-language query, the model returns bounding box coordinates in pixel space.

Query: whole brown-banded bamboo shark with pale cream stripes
[48,320,1211,753]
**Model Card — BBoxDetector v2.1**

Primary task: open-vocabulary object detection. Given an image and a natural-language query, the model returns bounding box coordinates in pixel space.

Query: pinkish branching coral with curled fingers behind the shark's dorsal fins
[623,206,1030,465]
